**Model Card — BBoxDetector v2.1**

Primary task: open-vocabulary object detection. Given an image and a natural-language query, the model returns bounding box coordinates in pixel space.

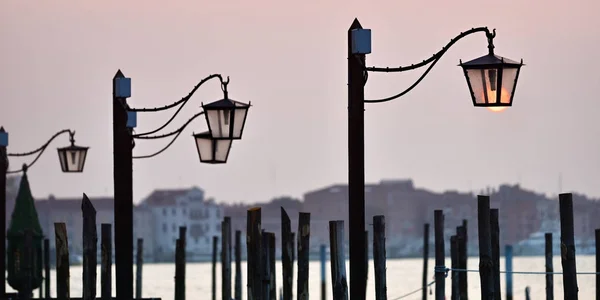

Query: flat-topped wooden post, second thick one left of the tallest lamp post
[296,212,310,300]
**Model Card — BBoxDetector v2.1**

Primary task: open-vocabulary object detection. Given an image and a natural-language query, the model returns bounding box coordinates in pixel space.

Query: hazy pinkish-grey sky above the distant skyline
[0,0,600,203]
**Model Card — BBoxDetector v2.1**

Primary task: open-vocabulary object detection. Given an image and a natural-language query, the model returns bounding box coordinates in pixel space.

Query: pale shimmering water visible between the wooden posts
[7,255,596,300]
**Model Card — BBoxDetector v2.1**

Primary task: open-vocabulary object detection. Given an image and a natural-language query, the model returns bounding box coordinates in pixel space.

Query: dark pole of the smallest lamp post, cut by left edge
[0,127,8,298]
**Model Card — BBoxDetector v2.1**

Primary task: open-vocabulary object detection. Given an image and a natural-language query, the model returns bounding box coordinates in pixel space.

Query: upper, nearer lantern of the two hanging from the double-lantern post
[202,94,250,140]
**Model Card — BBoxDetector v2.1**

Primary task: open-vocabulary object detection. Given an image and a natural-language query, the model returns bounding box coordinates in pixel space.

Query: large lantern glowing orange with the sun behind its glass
[460,53,523,108]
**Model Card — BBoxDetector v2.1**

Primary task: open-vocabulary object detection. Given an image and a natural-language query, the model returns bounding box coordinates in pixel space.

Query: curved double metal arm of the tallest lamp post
[365,27,496,103]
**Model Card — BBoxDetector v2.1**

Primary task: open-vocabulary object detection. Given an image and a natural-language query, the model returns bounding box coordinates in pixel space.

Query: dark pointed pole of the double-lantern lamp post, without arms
[113,70,133,300]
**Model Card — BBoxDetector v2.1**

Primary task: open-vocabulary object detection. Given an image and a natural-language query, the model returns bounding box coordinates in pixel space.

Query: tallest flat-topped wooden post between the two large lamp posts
[246,207,263,300]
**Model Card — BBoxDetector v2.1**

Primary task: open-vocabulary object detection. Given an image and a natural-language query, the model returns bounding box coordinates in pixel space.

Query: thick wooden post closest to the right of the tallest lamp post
[373,216,387,300]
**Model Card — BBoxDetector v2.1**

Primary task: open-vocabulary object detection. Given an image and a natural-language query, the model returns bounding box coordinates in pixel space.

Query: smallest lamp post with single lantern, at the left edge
[0,127,89,297]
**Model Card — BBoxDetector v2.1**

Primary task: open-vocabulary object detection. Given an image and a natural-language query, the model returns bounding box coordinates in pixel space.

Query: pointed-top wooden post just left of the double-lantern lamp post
[81,194,98,300]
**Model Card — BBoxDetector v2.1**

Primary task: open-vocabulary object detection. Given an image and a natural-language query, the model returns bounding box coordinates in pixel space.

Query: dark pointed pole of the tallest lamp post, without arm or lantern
[348,19,367,300]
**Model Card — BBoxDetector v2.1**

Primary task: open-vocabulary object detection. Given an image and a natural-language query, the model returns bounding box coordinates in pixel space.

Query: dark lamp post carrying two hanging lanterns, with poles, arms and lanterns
[113,70,250,299]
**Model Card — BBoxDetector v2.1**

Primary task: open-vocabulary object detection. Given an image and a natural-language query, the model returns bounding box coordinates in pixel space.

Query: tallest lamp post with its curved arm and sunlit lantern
[348,19,523,300]
